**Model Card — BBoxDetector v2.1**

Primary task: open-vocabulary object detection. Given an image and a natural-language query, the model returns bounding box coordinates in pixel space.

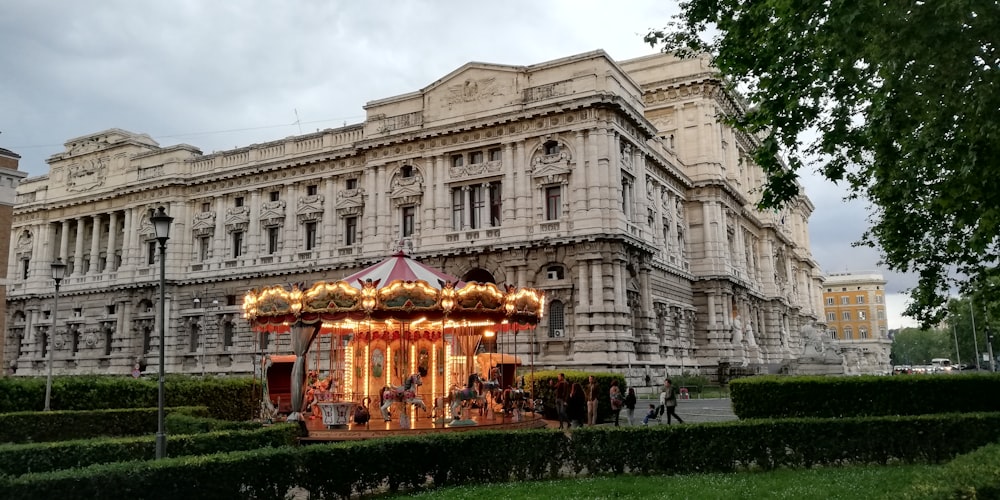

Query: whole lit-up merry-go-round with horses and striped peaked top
[243,252,545,438]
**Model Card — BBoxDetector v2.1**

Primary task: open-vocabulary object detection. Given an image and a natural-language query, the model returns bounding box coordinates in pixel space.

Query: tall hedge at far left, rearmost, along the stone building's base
[0,375,260,420]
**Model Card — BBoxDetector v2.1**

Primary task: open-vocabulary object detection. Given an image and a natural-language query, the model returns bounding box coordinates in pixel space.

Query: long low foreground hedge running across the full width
[0,413,1000,499]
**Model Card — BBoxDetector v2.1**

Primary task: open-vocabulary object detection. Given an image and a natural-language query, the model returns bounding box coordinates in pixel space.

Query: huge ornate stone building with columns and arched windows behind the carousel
[5,51,823,382]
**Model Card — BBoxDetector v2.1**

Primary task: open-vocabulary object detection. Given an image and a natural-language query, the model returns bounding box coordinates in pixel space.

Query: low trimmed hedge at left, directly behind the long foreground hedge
[0,424,298,476]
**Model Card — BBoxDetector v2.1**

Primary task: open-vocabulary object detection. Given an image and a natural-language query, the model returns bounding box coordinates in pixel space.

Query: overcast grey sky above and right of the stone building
[0,0,914,328]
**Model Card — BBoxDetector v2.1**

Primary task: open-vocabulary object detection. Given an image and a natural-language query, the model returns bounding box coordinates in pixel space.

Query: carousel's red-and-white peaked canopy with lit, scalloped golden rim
[243,253,545,332]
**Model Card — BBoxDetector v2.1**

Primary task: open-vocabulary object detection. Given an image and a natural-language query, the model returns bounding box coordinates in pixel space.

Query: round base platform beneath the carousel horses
[299,412,546,443]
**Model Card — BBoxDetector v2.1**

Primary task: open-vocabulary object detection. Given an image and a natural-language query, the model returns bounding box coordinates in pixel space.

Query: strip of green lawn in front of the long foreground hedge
[393,465,938,500]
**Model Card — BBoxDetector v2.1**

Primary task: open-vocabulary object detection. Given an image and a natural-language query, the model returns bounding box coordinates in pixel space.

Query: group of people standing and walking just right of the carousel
[555,373,684,429]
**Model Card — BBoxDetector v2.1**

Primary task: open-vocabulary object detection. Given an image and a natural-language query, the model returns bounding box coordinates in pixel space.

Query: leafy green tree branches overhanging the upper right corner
[646,0,1000,326]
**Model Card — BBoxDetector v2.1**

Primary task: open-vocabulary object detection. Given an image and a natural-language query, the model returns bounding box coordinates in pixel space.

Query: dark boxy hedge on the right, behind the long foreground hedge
[730,374,1000,419]
